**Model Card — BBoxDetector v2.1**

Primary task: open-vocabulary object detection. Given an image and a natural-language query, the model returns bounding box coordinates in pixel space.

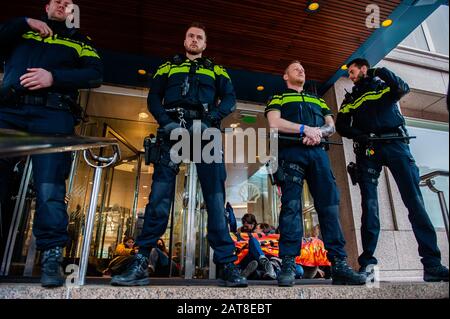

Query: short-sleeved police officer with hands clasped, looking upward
[265,61,366,287]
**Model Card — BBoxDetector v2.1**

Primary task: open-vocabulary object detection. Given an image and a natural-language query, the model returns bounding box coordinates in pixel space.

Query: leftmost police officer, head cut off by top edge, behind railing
[0,0,103,287]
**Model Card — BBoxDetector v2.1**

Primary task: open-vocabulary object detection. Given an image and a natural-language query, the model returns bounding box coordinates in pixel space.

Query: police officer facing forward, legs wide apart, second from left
[111,23,247,287]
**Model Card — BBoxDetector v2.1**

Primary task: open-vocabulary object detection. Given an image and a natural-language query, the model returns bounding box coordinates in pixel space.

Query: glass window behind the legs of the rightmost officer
[408,126,449,228]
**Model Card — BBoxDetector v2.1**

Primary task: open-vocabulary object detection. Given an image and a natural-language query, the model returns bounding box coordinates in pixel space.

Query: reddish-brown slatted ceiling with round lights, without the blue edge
[0,0,400,83]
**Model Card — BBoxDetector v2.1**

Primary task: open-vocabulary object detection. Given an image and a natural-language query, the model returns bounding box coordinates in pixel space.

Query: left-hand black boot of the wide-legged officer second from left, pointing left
[111,254,150,286]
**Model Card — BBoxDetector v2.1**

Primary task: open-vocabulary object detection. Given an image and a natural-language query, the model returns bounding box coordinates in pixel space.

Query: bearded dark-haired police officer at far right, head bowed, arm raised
[336,58,448,281]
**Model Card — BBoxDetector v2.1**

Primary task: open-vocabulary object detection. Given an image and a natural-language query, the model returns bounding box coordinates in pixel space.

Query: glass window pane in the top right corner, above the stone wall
[426,5,449,55]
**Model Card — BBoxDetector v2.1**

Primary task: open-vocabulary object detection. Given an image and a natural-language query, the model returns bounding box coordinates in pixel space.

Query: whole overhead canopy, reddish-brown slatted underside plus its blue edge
[0,0,447,102]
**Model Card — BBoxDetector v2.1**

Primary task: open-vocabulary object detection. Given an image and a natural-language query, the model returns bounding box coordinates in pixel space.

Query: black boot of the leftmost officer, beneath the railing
[41,247,64,288]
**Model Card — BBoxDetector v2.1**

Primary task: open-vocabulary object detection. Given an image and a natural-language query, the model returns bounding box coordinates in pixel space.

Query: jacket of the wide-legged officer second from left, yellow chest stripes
[148,55,236,126]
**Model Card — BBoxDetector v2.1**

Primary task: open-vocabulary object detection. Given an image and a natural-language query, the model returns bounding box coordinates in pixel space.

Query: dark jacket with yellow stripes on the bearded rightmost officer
[336,68,409,138]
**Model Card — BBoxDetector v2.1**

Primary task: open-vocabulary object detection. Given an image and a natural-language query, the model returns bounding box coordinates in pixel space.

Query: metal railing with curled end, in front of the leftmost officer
[0,129,121,285]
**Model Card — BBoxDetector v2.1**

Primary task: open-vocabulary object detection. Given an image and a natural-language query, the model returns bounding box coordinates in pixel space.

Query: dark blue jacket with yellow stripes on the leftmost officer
[0,17,103,98]
